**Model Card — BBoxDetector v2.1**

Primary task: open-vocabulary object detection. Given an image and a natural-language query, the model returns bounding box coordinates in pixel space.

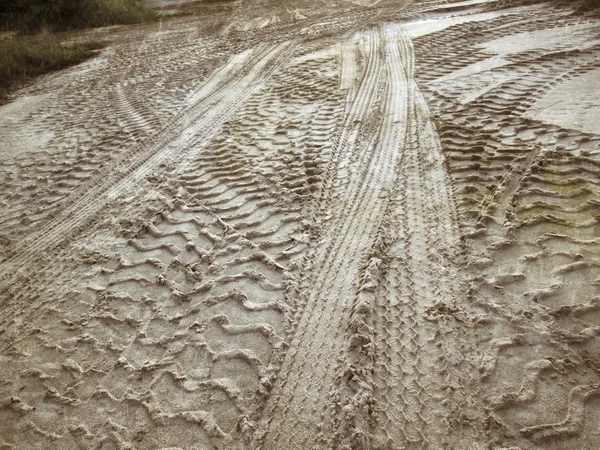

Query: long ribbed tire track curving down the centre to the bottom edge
[259,29,455,449]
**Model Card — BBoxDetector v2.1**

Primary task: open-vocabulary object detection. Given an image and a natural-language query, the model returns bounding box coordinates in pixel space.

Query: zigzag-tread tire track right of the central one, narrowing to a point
[374,53,460,449]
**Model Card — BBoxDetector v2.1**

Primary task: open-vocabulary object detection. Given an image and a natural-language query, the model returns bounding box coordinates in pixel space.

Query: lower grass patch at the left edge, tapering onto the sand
[0,34,105,102]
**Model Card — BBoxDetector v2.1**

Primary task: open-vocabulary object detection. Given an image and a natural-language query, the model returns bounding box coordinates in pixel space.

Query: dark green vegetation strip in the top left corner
[0,0,156,34]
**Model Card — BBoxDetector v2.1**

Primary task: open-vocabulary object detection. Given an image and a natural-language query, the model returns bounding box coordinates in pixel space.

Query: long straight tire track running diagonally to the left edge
[0,42,294,288]
